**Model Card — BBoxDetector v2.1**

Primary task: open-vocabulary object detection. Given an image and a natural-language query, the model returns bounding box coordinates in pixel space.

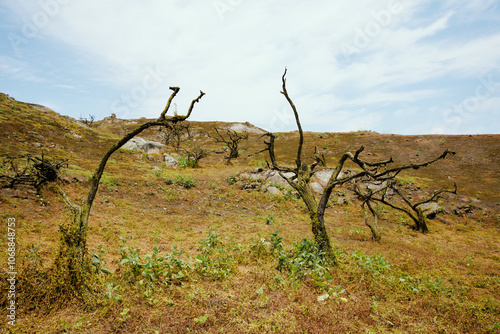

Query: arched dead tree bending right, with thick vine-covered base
[54,87,205,298]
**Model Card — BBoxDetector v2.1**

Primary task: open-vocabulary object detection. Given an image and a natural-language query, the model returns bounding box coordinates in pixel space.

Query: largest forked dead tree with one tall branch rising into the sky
[263,69,454,260]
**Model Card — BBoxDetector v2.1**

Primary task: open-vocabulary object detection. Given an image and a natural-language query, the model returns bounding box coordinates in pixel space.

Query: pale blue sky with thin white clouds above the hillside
[0,0,500,135]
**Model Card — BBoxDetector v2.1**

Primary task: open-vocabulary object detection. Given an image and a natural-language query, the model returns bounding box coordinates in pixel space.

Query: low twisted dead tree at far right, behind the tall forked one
[352,179,457,234]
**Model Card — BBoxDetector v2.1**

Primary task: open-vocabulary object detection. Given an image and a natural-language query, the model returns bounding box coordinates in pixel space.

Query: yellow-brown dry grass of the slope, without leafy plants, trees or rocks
[0,96,500,333]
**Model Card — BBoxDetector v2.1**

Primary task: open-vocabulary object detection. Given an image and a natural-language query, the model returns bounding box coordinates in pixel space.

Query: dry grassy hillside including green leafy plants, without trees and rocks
[0,95,500,333]
